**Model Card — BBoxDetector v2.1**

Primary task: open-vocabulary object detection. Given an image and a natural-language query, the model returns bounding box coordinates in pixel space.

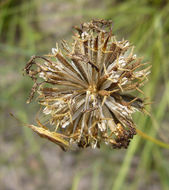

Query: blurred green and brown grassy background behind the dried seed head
[0,0,169,190]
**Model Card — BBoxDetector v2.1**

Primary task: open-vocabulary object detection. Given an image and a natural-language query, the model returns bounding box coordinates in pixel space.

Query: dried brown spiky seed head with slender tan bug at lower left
[25,20,150,150]
